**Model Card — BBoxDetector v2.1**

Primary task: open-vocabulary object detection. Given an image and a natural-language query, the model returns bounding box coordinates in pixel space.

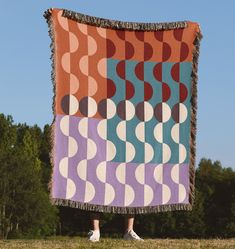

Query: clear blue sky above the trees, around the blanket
[0,0,235,169]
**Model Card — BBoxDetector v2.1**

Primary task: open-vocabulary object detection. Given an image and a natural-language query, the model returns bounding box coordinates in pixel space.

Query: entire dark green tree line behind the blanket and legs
[0,114,235,239]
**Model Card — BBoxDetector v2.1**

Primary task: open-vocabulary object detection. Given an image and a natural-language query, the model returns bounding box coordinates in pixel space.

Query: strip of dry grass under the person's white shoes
[0,237,235,249]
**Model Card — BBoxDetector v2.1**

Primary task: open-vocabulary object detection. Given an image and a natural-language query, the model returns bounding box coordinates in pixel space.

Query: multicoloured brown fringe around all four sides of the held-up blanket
[43,9,202,214]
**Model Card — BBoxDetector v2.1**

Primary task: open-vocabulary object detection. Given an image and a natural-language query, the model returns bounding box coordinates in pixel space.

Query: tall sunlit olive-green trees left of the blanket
[0,115,58,238]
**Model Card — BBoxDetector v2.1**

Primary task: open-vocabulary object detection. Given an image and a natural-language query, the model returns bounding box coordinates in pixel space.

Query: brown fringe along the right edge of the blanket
[189,27,202,206]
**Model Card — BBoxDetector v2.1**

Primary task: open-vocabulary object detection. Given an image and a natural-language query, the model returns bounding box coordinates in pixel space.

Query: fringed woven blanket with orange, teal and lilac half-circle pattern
[44,8,202,213]
